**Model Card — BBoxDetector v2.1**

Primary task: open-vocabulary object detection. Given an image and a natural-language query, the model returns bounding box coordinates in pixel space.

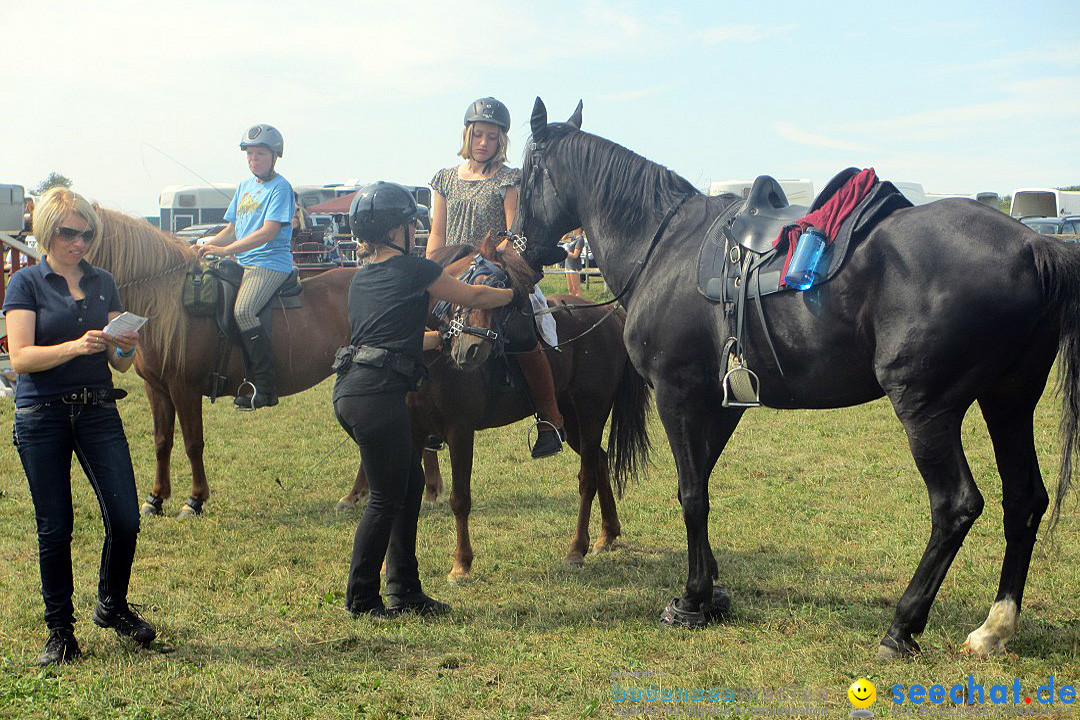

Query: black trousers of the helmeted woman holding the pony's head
[334,391,423,612]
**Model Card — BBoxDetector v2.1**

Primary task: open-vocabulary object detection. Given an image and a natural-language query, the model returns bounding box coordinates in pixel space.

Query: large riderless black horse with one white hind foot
[514,98,1080,657]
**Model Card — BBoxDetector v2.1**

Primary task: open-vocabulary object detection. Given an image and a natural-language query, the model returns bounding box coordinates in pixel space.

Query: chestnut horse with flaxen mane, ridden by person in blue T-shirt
[87,208,355,516]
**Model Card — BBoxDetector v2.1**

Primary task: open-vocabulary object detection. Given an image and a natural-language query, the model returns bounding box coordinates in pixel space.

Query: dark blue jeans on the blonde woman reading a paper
[12,402,139,629]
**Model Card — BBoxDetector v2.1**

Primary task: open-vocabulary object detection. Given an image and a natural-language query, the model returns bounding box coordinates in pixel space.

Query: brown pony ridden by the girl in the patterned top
[339,239,650,581]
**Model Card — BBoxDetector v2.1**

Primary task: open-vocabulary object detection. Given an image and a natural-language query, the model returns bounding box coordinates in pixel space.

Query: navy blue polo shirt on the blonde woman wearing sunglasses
[3,258,123,407]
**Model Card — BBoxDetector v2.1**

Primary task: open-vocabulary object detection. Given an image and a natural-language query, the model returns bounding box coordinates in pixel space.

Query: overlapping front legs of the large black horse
[657,383,743,627]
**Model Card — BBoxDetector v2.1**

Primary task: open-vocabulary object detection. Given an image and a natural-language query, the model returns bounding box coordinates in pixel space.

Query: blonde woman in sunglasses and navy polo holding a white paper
[3,188,157,665]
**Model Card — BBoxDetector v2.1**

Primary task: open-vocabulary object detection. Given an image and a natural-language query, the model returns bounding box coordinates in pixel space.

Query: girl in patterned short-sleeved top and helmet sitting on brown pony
[428,97,565,458]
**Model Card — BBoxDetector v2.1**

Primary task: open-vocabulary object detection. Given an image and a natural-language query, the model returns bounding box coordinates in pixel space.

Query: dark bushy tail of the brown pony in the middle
[607,357,652,499]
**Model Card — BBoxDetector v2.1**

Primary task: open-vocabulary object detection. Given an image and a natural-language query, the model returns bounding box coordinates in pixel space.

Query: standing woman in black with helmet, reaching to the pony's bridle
[334,182,514,617]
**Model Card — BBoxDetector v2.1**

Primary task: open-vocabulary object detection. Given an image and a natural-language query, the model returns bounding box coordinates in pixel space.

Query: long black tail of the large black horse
[1031,239,1080,543]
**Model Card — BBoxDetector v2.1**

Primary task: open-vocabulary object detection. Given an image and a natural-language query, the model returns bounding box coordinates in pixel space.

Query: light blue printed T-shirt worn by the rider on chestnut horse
[225,175,296,272]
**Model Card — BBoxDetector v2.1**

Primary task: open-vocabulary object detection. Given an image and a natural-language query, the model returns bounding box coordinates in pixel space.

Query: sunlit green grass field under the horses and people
[0,281,1080,720]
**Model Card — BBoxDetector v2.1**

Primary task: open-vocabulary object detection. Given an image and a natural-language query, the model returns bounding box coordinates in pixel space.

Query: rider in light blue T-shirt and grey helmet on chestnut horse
[199,124,295,410]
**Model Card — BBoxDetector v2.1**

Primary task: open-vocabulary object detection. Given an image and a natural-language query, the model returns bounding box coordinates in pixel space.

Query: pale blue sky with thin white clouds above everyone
[0,0,1080,215]
